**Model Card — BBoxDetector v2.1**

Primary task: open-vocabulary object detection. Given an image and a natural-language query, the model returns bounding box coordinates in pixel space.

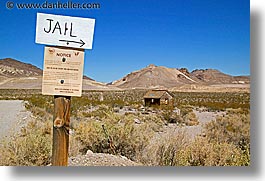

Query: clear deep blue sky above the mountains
[0,0,250,82]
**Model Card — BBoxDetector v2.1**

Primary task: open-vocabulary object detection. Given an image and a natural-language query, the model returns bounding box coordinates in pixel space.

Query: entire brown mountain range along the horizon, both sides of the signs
[0,58,250,90]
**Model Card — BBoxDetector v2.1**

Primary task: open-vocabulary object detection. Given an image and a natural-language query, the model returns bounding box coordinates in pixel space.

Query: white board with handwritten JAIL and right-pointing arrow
[36,13,95,49]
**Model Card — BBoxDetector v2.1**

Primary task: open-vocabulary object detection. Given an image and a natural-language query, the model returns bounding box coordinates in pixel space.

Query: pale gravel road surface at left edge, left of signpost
[0,100,31,139]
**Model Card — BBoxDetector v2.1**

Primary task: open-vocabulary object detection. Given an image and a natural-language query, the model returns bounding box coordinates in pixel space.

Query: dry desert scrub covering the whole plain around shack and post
[0,90,250,166]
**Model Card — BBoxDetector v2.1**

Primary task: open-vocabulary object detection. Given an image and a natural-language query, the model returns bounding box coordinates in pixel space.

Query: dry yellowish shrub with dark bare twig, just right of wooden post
[74,122,147,160]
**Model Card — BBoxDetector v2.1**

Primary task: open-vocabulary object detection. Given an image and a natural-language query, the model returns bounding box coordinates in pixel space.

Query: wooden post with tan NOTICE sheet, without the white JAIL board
[42,46,84,166]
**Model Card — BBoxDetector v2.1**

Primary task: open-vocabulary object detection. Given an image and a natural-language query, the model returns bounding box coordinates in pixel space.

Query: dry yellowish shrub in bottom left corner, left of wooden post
[0,121,51,166]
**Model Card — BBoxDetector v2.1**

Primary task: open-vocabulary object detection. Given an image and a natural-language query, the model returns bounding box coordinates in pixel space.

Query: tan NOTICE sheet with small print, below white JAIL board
[42,47,84,97]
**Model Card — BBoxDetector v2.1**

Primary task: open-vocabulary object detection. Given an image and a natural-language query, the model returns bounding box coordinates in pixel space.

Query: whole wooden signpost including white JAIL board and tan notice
[36,13,95,166]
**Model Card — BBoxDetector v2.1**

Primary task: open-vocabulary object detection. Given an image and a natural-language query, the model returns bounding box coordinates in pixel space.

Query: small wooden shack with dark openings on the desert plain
[144,90,174,106]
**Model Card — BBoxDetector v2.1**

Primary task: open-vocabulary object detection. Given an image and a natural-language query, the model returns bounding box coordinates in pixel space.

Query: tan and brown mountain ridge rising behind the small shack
[109,65,249,88]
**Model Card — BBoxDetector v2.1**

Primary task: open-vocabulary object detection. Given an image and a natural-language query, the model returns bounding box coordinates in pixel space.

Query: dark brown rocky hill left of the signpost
[0,58,42,78]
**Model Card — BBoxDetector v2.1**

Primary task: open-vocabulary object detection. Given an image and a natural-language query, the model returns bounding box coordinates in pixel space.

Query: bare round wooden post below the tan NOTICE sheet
[52,96,71,166]
